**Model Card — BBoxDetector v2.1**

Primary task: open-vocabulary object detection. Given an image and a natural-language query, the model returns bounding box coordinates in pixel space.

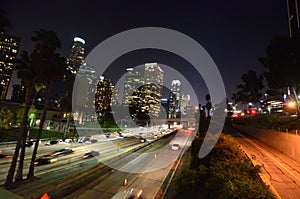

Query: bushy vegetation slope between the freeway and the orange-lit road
[175,133,275,198]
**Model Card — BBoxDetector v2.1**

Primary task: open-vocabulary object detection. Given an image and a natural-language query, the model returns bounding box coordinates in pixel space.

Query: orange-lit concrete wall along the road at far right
[234,124,300,163]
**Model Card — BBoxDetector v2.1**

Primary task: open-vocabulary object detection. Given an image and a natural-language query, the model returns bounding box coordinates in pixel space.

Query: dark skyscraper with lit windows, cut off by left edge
[0,32,20,100]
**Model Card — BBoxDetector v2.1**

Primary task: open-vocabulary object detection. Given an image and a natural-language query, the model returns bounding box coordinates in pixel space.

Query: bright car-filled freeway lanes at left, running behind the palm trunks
[0,138,141,184]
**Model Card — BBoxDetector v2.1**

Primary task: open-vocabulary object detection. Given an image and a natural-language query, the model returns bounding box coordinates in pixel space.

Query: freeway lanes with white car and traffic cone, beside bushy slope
[72,130,193,199]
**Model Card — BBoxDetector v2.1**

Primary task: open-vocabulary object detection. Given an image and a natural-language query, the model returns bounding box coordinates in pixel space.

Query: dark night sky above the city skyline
[1,0,288,105]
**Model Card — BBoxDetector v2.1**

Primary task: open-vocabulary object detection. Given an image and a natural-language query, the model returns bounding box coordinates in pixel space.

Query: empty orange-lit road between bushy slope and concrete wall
[233,127,300,199]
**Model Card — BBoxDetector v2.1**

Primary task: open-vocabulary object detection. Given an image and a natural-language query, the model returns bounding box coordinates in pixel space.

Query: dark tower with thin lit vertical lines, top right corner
[286,0,300,37]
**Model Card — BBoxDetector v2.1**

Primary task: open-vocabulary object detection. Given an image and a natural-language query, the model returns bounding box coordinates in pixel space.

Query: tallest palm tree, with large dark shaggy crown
[27,30,66,179]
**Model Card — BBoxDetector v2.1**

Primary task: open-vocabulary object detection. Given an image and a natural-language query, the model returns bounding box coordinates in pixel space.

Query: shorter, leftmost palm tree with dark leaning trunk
[5,51,37,187]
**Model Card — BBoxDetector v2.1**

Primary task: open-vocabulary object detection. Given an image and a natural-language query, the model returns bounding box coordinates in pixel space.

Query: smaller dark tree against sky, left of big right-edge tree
[233,70,264,103]
